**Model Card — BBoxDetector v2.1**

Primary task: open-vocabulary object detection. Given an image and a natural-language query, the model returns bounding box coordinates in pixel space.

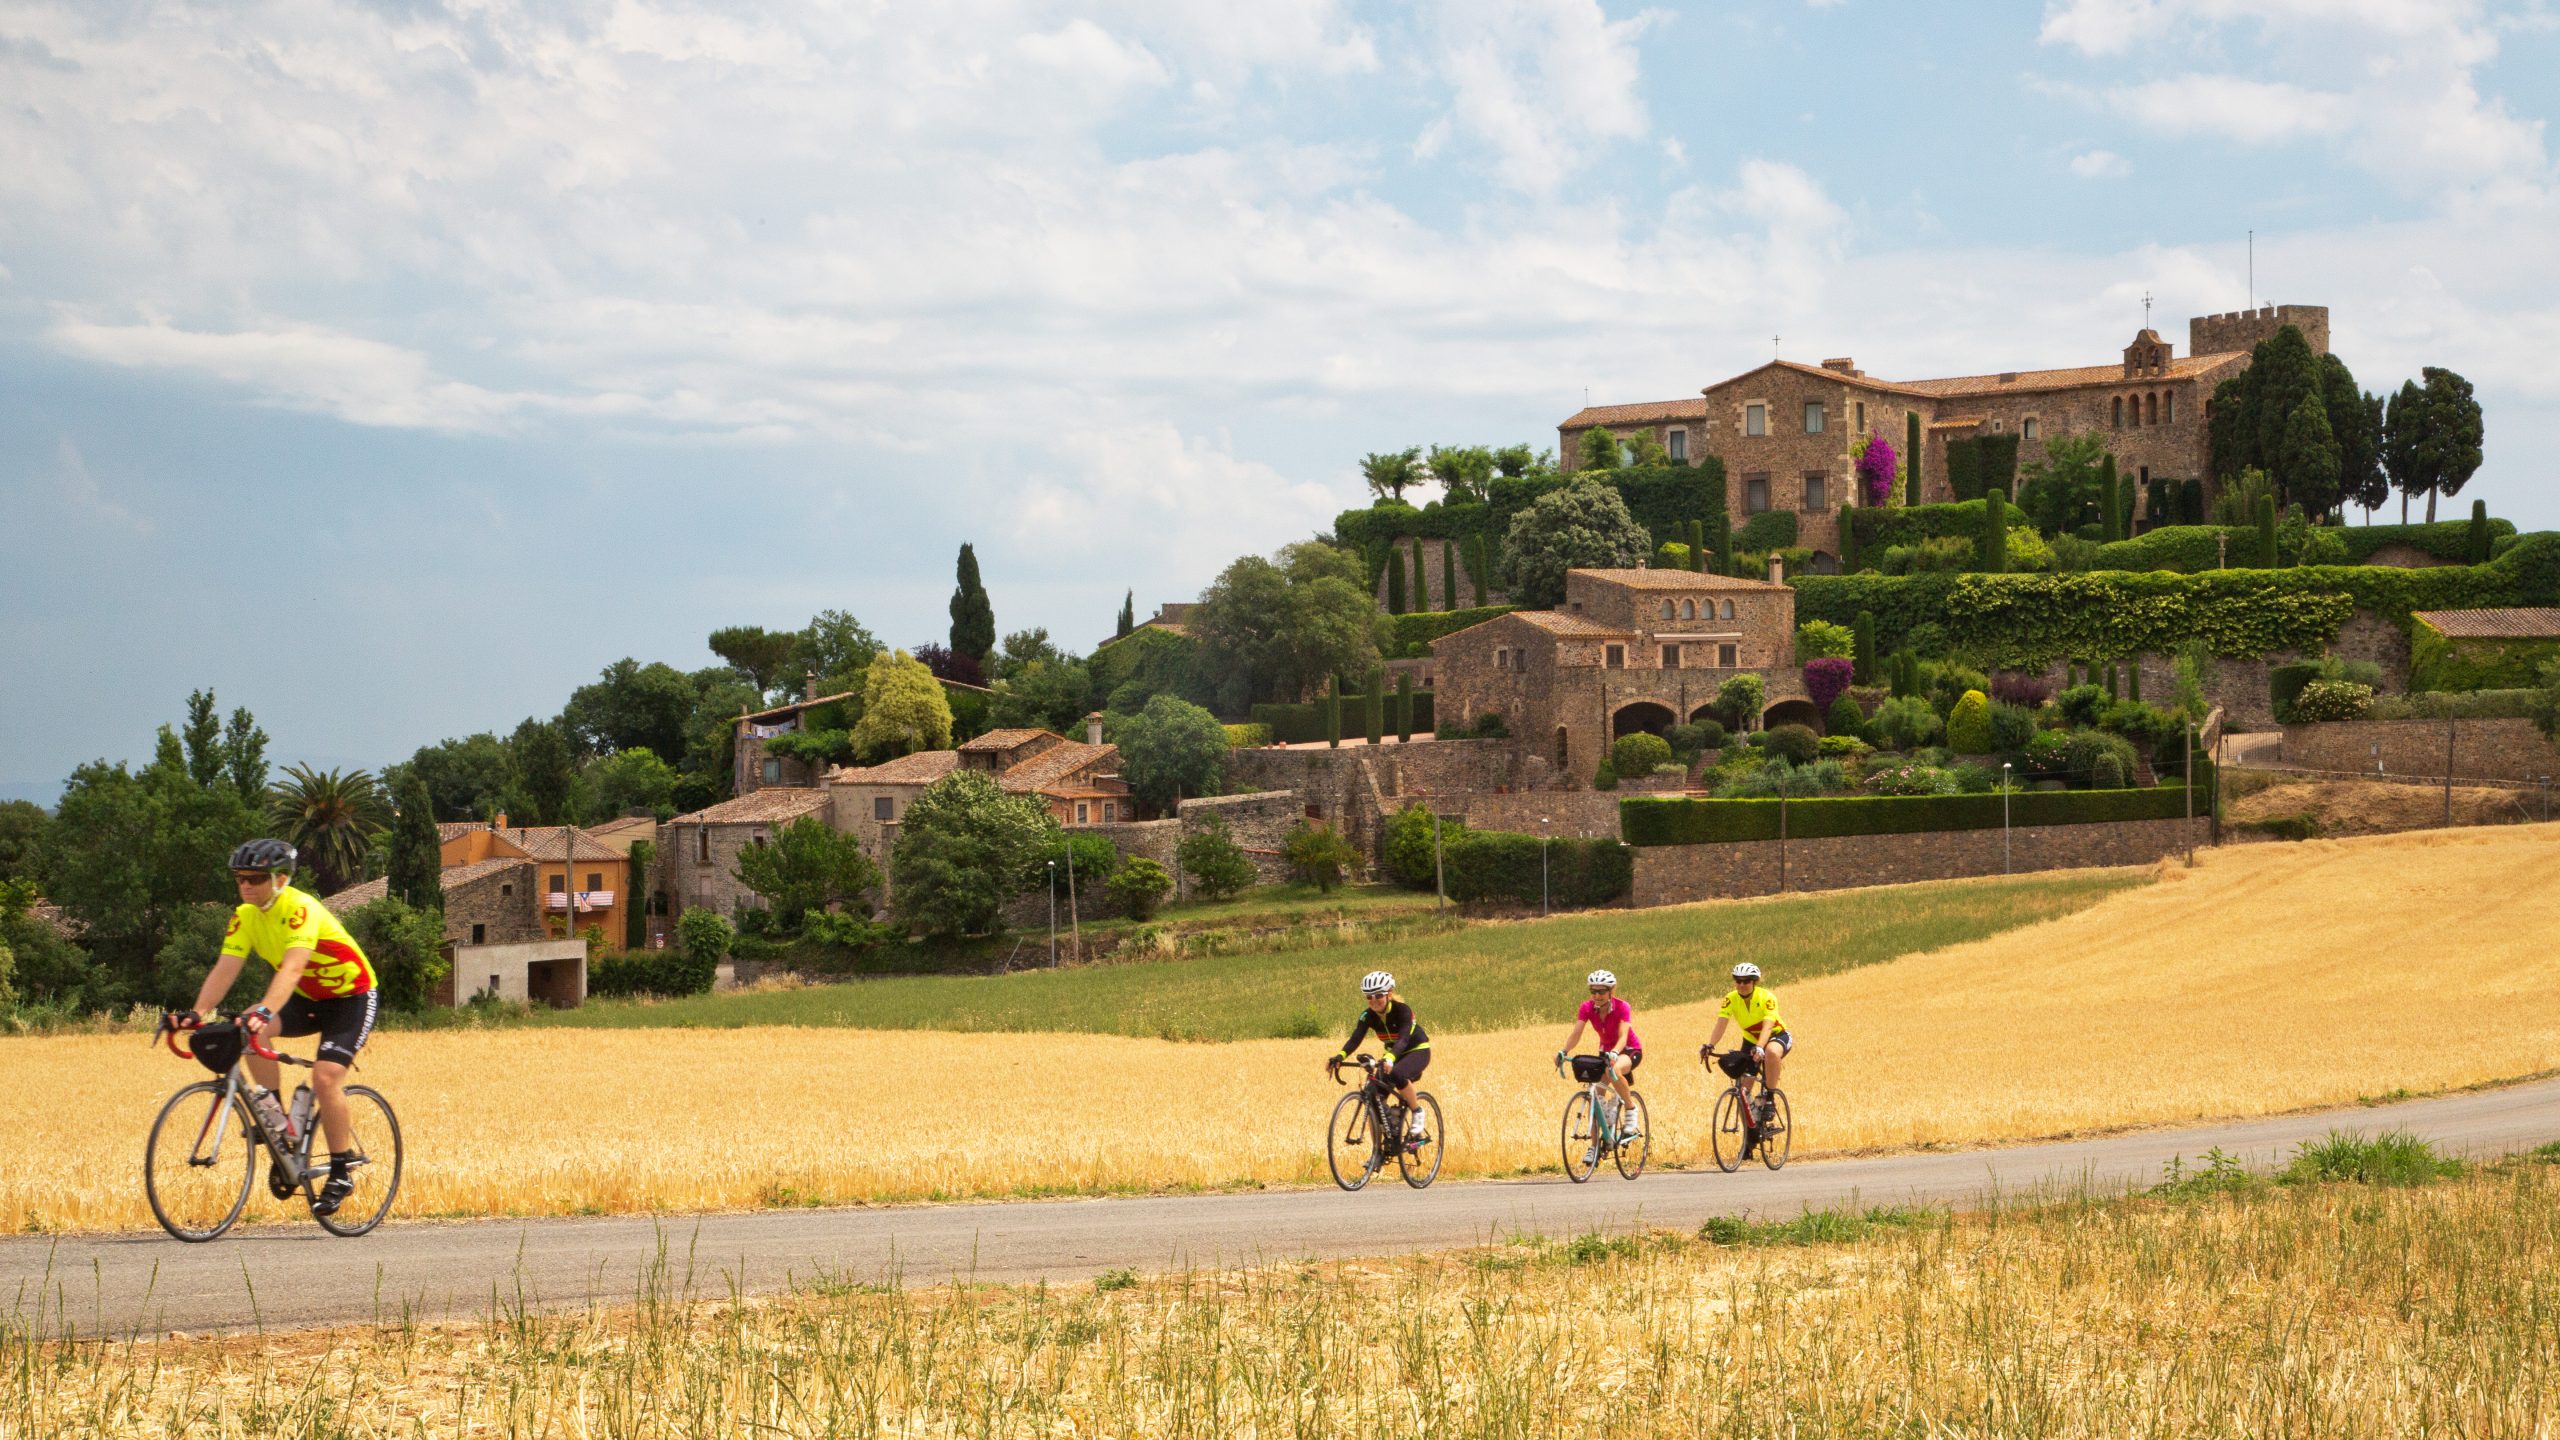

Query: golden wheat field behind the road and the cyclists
[0,825,2560,1230]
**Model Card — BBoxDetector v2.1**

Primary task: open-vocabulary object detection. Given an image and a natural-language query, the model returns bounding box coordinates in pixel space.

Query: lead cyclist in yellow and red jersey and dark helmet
[179,840,381,1215]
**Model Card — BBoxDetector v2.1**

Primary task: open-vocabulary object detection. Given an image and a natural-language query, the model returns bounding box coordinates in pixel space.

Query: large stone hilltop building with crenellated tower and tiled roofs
[1556,305,2330,571]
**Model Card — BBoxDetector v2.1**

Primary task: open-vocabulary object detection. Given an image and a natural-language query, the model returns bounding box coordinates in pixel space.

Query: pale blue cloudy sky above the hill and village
[0,0,2560,799]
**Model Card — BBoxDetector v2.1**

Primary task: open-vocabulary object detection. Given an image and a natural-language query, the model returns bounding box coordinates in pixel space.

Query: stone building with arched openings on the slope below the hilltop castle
[1431,569,1820,781]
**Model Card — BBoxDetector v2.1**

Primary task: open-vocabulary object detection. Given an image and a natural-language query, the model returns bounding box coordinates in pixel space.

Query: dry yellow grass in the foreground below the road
[15,1166,2560,1440]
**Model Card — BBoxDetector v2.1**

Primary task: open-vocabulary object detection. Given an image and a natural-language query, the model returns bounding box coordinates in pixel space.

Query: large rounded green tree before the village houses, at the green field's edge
[888,771,1057,938]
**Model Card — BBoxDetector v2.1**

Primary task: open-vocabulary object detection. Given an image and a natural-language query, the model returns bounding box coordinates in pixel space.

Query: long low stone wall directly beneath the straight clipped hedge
[1633,817,2209,904]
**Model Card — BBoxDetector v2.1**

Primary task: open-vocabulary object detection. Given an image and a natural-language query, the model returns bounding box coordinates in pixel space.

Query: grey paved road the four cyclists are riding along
[0,1081,2560,1335]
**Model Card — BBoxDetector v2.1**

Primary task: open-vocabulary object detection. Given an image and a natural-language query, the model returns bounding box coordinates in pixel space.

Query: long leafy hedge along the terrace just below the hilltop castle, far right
[1789,533,2560,669]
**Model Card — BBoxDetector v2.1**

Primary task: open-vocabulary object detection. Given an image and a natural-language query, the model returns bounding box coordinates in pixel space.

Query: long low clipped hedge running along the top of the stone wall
[1618,761,2214,846]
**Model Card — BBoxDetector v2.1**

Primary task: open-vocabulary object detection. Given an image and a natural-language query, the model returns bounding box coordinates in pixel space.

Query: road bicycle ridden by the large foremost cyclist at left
[143,1017,402,1243]
